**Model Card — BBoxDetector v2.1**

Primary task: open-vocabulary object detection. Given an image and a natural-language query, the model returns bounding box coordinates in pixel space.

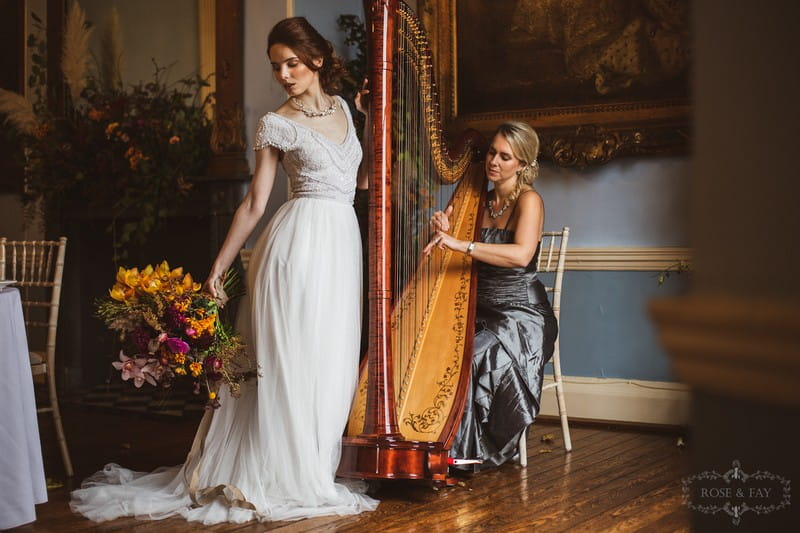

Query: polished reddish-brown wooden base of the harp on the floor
[336,436,448,486]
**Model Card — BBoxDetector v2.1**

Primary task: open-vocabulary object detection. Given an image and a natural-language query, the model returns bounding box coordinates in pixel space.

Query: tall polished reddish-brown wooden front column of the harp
[362,0,402,440]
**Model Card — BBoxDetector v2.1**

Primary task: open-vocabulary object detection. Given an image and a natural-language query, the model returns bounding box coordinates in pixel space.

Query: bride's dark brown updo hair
[267,17,346,93]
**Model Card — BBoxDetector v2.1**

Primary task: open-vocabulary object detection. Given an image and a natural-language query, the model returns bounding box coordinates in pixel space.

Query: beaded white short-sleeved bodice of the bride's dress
[253,96,361,203]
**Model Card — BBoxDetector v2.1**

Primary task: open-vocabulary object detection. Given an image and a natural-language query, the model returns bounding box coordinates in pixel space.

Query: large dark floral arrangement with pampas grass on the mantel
[0,2,211,251]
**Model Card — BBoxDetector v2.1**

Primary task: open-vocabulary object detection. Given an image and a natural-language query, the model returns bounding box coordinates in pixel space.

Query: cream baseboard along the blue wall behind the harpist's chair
[541,376,689,426]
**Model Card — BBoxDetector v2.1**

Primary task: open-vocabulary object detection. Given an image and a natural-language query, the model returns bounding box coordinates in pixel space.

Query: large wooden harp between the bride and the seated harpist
[338,0,486,484]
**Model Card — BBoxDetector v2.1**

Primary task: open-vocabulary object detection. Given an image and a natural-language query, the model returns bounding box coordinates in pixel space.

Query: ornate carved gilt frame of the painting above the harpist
[418,0,691,168]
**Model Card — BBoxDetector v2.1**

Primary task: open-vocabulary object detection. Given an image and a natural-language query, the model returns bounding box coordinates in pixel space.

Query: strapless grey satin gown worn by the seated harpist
[450,228,558,470]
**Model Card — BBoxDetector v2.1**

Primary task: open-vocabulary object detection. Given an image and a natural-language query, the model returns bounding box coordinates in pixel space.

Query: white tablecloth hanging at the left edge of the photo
[0,288,47,529]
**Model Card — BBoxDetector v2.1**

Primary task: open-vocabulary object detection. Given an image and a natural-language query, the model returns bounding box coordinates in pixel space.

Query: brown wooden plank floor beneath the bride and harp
[11,407,689,533]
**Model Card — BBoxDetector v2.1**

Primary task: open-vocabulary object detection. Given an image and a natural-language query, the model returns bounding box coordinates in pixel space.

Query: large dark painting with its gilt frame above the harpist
[419,0,691,166]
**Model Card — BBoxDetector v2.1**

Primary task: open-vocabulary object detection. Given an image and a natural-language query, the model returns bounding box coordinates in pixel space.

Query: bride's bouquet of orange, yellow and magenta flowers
[97,261,256,408]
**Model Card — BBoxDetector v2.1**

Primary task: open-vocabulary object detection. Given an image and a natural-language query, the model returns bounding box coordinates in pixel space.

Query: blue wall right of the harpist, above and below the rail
[536,157,690,381]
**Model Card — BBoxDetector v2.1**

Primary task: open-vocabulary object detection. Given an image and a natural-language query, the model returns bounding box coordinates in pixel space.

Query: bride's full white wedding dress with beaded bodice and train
[70,98,378,524]
